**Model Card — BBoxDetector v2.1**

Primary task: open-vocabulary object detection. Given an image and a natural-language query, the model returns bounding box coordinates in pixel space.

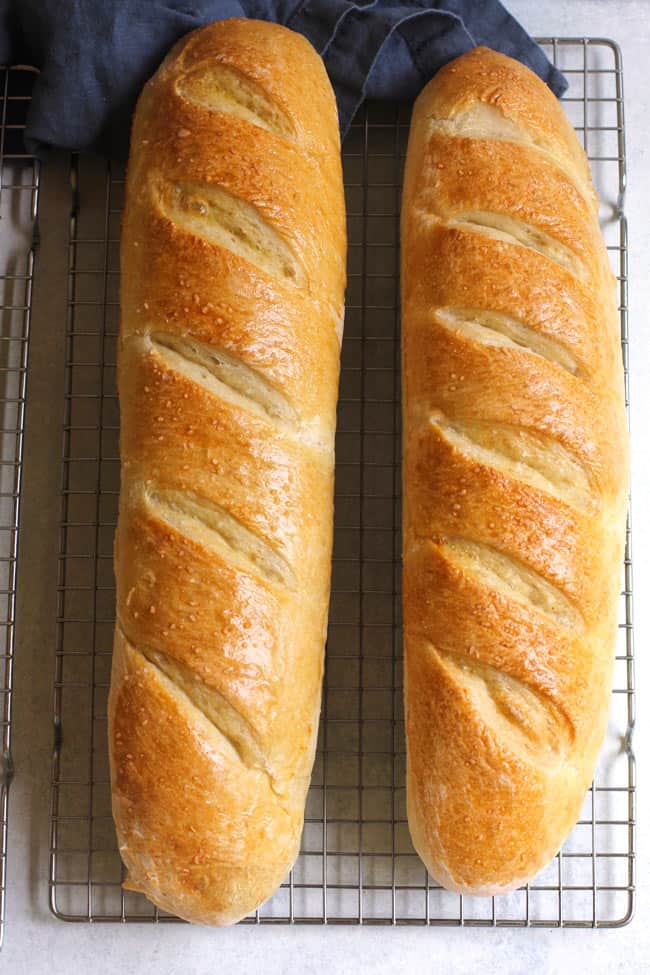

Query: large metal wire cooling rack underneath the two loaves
[50,39,635,927]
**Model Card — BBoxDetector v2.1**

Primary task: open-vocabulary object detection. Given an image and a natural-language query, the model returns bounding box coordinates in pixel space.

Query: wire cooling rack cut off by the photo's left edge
[0,67,39,944]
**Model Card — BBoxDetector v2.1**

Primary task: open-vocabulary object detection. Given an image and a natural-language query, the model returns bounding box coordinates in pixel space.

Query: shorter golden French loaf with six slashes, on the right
[402,48,628,895]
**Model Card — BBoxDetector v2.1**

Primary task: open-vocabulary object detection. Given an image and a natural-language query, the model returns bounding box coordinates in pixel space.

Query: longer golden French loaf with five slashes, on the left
[109,20,346,925]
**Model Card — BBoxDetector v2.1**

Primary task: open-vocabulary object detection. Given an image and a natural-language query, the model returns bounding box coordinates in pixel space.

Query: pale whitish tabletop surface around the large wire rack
[5,0,650,975]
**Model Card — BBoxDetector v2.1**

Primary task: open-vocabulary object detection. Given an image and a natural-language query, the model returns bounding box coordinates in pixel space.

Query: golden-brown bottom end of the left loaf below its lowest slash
[111,629,302,924]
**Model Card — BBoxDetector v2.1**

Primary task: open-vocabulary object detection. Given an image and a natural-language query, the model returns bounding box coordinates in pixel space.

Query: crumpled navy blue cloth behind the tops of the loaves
[0,0,566,159]
